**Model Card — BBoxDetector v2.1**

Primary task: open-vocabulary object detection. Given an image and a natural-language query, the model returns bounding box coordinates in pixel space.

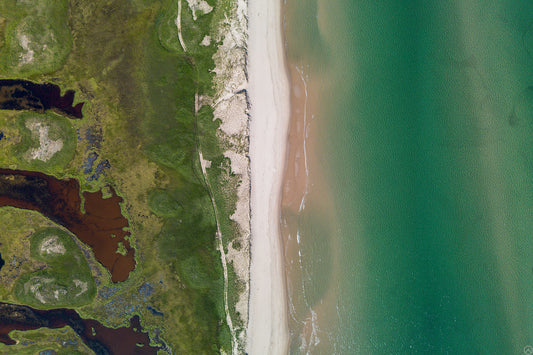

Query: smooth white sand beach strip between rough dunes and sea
[247,0,290,355]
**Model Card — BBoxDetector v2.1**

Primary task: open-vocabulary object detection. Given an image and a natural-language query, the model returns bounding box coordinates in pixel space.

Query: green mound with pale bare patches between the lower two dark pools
[15,228,96,309]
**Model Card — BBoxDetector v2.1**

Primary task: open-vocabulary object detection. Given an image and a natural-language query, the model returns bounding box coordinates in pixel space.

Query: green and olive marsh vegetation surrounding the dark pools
[0,0,243,354]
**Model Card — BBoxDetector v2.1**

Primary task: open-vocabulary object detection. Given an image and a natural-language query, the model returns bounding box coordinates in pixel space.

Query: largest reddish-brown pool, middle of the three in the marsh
[0,169,135,282]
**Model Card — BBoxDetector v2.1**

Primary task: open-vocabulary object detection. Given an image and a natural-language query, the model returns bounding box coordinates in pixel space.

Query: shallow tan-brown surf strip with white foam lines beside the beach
[281,0,341,354]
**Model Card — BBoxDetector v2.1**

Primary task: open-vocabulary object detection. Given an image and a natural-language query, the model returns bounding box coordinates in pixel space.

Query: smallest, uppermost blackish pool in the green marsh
[0,79,84,118]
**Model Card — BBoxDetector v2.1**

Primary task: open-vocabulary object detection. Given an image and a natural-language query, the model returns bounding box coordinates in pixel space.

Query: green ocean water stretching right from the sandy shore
[285,0,533,354]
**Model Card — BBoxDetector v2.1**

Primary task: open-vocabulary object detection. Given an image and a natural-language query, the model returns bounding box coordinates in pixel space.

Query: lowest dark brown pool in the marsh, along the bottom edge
[0,302,160,355]
